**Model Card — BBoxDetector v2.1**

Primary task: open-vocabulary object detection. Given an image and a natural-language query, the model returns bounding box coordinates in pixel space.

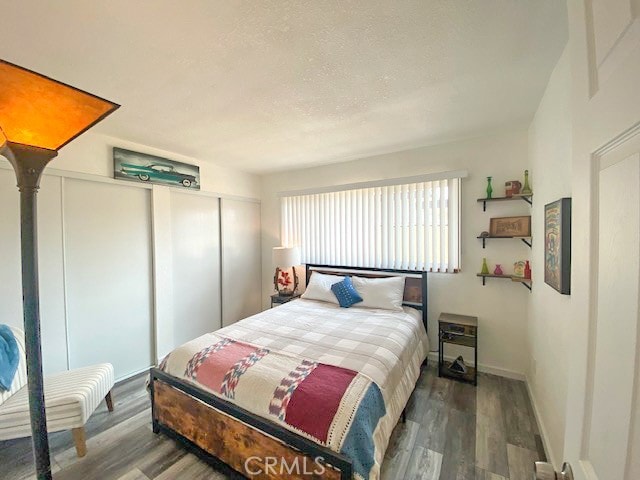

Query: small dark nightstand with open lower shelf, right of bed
[438,313,478,385]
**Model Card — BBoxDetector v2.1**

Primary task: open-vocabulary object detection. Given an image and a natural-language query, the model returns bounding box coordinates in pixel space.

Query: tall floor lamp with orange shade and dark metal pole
[0,60,119,480]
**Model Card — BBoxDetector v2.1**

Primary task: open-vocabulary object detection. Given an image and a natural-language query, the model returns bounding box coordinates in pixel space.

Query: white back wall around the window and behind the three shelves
[262,127,541,377]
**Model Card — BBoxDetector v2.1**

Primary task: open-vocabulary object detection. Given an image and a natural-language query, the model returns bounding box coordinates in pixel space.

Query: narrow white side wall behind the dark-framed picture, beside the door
[527,50,572,466]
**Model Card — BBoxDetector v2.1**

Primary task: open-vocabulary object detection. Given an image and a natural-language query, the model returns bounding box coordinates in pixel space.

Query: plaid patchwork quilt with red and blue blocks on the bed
[160,300,428,480]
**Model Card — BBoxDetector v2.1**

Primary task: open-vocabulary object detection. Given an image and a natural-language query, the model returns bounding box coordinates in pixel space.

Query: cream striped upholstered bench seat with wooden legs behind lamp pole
[0,327,114,457]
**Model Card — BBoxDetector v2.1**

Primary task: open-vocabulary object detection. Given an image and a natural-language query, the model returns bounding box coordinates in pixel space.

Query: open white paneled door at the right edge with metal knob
[564,0,640,480]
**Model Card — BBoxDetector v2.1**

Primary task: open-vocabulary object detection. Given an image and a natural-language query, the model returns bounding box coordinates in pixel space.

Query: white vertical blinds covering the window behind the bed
[281,178,460,272]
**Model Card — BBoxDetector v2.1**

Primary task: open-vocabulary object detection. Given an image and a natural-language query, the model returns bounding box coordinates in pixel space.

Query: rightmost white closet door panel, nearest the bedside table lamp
[221,198,262,327]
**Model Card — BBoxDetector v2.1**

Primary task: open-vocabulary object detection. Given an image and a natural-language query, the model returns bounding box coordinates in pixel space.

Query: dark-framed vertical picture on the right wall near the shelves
[544,198,571,295]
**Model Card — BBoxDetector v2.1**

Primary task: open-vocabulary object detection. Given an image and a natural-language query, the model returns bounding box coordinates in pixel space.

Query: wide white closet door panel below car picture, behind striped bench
[64,179,153,378]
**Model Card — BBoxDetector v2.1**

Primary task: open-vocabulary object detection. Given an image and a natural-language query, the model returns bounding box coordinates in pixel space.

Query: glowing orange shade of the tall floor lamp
[0,60,119,150]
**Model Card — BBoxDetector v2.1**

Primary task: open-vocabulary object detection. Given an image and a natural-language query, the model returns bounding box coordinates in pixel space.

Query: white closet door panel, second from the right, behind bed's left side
[171,191,221,345]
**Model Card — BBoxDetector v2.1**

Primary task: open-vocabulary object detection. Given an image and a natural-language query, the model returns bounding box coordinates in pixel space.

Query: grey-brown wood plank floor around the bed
[0,367,545,480]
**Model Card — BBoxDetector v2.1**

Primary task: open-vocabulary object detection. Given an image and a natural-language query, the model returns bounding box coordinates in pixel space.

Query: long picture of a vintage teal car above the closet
[113,147,200,190]
